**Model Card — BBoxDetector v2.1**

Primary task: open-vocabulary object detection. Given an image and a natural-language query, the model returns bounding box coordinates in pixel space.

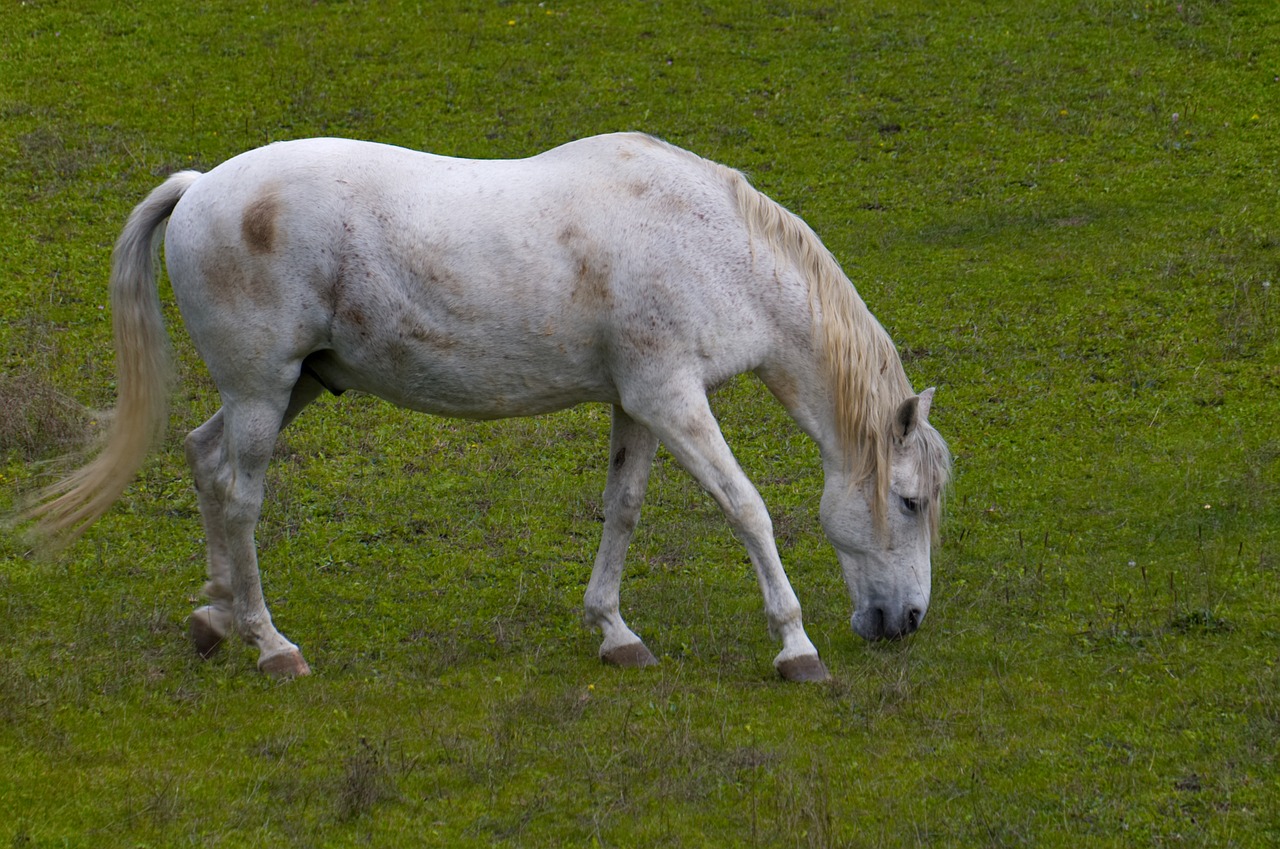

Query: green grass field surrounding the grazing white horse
[0,0,1280,848]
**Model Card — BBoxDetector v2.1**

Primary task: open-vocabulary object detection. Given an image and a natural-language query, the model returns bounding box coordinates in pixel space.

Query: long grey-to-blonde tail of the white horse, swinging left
[23,172,200,549]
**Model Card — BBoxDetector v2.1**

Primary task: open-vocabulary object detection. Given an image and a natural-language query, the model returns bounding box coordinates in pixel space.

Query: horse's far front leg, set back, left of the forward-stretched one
[584,406,658,666]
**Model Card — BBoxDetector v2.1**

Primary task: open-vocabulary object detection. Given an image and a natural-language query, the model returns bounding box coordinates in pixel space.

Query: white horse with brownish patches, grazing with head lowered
[28,133,950,680]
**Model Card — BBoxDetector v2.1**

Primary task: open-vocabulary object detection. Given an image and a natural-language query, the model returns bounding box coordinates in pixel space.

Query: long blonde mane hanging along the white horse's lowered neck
[721,166,921,525]
